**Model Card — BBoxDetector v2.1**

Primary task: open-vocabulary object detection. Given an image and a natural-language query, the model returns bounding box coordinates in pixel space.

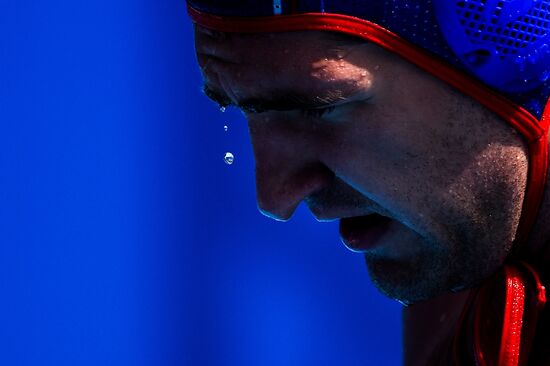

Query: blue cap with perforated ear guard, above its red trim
[188,0,550,119]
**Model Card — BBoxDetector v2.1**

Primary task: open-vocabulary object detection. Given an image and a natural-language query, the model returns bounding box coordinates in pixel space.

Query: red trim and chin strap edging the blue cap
[188,7,550,366]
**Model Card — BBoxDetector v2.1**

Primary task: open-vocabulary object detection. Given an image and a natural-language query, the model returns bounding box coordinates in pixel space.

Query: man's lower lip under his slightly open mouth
[340,214,391,252]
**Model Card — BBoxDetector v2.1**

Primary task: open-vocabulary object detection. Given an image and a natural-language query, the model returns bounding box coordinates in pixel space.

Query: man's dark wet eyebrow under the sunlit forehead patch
[202,84,357,113]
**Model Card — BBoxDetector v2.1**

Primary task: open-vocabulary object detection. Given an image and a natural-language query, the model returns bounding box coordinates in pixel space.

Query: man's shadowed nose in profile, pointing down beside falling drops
[248,117,334,221]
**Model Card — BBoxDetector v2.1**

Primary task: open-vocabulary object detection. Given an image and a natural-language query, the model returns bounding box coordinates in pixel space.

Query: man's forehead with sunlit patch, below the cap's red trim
[195,26,382,104]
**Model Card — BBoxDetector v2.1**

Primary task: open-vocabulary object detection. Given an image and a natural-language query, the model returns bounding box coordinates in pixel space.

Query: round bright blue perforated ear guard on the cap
[434,0,550,93]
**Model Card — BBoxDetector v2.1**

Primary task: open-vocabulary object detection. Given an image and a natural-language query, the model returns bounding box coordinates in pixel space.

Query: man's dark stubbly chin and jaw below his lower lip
[364,219,511,305]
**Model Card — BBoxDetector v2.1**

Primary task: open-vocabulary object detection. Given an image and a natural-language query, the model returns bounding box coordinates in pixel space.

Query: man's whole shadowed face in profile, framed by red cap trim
[196,27,527,303]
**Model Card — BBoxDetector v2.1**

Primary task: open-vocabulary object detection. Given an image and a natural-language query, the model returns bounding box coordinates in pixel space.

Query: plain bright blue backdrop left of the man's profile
[0,0,402,366]
